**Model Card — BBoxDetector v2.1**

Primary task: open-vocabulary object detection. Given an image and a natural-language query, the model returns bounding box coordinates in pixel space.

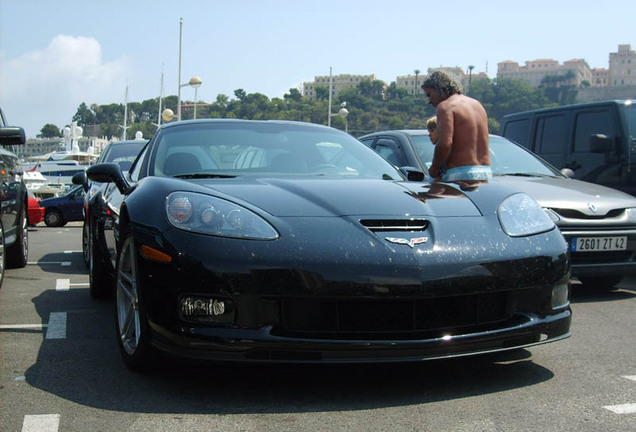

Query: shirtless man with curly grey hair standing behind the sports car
[422,71,492,181]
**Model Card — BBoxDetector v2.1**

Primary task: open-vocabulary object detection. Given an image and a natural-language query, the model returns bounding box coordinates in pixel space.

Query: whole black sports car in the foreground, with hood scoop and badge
[79,120,571,369]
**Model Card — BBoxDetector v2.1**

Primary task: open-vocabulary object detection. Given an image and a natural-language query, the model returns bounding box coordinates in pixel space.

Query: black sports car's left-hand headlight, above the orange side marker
[166,192,278,240]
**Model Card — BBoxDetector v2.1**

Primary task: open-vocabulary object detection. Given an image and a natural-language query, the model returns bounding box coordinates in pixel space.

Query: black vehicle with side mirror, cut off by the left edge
[0,109,29,287]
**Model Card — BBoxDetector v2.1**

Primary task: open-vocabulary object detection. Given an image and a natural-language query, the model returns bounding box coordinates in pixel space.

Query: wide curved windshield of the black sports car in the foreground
[148,121,403,180]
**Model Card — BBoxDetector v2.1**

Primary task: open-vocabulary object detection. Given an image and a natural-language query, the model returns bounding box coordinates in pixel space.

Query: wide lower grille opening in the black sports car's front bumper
[282,292,512,339]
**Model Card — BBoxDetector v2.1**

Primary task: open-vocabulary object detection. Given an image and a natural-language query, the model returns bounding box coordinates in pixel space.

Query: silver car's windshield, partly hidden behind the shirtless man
[411,135,562,176]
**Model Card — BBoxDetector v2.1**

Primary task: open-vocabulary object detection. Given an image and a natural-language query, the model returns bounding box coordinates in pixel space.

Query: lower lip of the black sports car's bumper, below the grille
[151,308,572,363]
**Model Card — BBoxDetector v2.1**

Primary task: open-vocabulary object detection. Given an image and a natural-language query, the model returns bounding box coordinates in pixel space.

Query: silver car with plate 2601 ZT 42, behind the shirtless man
[360,130,636,289]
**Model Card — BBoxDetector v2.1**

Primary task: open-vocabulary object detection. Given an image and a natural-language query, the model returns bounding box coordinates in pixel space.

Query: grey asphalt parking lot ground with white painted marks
[0,223,636,432]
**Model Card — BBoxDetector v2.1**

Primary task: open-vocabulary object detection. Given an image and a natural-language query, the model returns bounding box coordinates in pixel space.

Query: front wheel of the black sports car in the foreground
[115,236,157,372]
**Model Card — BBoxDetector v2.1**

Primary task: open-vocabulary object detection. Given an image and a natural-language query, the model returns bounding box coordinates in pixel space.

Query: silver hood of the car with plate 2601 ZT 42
[495,175,636,216]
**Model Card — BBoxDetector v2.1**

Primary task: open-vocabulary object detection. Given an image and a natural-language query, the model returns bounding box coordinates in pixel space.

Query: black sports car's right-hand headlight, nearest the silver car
[497,193,555,237]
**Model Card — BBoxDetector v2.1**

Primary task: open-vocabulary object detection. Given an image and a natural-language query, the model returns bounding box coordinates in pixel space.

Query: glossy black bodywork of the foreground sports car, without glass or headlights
[87,122,571,368]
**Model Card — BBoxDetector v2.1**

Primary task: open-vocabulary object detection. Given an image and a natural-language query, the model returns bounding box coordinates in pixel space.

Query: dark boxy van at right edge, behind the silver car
[501,100,636,195]
